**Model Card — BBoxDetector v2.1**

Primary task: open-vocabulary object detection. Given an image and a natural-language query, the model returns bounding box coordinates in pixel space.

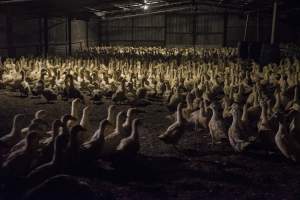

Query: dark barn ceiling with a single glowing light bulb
[0,0,300,19]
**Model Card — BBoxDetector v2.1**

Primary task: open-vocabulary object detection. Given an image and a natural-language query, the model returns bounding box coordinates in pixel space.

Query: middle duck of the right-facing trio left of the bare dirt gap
[101,111,125,156]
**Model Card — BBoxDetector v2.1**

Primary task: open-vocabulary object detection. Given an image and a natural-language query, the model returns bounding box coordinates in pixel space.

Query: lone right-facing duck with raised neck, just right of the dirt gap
[158,103,185,146]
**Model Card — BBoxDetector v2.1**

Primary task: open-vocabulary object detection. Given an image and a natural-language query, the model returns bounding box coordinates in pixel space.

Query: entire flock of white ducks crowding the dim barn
[0,47,300,198]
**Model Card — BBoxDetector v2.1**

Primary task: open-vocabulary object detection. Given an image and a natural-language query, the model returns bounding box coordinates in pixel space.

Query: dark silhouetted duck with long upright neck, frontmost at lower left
[27,129,64,185]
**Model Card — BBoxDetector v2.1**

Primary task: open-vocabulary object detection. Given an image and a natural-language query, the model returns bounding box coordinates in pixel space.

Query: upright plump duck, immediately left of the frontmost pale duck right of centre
[208,102,227,144]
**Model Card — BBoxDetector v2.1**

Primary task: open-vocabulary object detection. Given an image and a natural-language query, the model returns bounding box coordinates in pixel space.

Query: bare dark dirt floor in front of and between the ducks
[0,91,300,200]
